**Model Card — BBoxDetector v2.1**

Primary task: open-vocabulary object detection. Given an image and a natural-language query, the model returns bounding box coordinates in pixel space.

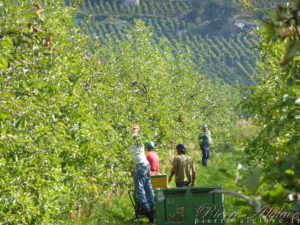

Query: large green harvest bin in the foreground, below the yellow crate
[154,186,225,225]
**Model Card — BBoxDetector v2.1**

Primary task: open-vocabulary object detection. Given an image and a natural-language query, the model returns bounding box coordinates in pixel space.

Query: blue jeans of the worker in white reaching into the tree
[134,164,155,211]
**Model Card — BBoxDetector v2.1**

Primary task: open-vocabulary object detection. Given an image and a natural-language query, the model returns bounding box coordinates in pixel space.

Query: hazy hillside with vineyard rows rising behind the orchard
[66,0,284,85]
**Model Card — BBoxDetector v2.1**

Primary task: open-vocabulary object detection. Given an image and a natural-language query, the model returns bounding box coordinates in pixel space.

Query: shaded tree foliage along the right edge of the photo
[236,0,300,223]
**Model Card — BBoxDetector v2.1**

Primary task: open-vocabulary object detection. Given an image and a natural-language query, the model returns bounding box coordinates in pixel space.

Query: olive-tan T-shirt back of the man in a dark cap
[173,154,194,182]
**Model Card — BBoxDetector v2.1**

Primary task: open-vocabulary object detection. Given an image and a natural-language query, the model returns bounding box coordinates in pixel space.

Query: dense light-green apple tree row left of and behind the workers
[0,0,236,224]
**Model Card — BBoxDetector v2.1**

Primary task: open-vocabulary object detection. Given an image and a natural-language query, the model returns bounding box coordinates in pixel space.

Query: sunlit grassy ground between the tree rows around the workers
[64,145,243,225]
